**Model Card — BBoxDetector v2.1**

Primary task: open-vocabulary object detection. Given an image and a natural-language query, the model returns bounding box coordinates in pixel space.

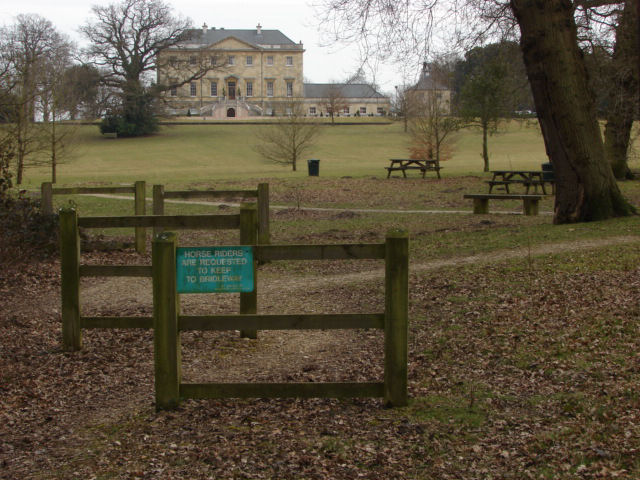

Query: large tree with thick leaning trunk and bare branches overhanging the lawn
[323,0,635,223]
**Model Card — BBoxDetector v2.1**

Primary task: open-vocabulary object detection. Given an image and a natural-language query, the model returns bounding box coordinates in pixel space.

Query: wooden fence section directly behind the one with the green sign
[60,204,257,351]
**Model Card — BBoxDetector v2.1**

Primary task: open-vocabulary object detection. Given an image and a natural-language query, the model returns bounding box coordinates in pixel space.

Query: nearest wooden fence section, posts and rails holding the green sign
[152,226,409,409]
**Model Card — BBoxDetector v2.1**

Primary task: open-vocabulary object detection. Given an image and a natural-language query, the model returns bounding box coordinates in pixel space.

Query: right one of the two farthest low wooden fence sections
[153,183,271,245]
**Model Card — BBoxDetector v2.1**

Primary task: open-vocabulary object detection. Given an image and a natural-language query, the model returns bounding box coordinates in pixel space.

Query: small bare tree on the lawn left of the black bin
[254,101,320,172]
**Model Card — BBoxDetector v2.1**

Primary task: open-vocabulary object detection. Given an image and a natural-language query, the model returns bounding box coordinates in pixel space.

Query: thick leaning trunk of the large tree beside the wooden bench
[511,0,634,223]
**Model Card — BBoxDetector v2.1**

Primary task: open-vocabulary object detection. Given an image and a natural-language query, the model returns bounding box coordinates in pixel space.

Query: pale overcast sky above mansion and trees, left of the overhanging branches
[0,0,402,93]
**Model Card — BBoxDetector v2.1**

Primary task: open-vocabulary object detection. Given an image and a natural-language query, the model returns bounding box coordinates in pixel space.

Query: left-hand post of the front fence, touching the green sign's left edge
[151,232,181,410]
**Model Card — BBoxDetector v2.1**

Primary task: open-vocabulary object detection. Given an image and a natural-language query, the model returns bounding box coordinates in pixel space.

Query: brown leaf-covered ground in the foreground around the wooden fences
[0,181,640,479]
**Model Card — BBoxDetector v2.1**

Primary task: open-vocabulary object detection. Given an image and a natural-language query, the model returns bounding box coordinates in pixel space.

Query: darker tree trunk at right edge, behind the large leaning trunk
[604,0,640,179]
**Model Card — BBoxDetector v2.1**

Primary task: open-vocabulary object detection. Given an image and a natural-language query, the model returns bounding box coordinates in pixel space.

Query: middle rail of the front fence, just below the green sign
[178,313,384,331]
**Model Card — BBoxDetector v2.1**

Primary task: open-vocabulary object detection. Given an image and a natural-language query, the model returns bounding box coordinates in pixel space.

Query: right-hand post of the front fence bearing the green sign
[384,230,409,407]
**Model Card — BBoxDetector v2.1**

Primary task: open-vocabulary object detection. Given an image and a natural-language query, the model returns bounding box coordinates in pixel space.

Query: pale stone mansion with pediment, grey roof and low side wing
[157,24,390,119]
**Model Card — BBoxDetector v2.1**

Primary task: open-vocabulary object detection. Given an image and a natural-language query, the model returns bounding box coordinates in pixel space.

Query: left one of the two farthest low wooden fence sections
[40,181,147,253]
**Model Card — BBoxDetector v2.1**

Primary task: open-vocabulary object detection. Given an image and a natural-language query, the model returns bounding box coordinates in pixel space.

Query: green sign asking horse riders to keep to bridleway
[176,247,254,293]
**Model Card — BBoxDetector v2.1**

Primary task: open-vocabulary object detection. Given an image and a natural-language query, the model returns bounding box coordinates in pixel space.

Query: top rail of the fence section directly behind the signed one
[78,215,240,230]
